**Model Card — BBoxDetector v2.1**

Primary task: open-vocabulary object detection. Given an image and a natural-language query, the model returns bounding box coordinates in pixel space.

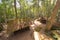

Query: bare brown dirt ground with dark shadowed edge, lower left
[0,29,33,40]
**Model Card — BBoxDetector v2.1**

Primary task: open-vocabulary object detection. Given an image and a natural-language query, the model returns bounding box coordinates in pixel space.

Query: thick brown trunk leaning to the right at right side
[47,0,60,30]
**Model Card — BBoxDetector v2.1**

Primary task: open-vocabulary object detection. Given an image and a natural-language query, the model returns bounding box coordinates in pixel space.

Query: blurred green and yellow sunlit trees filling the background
[0,0,60,23]
